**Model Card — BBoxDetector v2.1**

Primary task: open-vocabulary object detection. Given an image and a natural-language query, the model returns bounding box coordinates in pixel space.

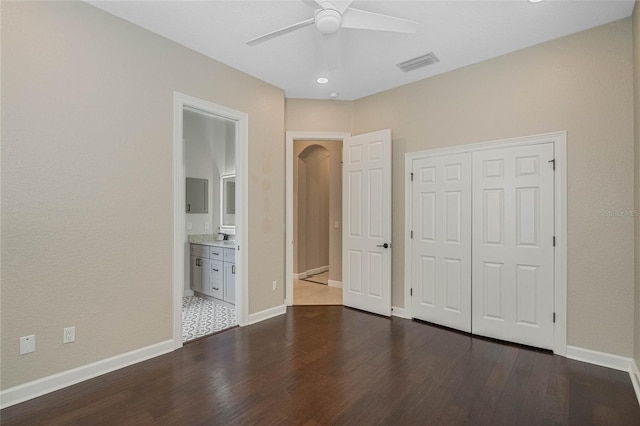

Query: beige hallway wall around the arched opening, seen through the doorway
[293,141,342,282]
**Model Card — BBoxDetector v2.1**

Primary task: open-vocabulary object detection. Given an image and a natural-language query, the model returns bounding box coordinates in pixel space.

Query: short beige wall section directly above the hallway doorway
[285,99,353,133]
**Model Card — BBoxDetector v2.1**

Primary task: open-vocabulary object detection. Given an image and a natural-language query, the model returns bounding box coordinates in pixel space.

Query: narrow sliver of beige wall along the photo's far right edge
[633,0,640,366]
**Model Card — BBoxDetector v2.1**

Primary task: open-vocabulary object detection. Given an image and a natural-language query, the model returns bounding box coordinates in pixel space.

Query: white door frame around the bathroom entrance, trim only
[173,92,249,349]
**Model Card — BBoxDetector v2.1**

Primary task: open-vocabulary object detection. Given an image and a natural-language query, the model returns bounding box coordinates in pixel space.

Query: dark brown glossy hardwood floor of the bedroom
[0,306,640,425]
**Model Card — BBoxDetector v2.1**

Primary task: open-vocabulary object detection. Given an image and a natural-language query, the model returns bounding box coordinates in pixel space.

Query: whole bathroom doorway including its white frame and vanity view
[173,93,248,348]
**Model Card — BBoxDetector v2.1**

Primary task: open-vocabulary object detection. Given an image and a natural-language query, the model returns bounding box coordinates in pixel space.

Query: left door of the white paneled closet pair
[411,153,471,332]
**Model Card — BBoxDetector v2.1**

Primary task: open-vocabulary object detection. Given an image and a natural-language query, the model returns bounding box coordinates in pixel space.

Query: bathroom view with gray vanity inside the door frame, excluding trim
[182,107,237,343]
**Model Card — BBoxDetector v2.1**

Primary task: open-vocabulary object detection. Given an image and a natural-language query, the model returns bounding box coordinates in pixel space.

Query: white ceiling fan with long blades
[247,0,418,69]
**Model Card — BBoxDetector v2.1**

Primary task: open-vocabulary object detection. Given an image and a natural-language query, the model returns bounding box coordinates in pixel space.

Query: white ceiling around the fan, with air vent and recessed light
[89,0,634,100]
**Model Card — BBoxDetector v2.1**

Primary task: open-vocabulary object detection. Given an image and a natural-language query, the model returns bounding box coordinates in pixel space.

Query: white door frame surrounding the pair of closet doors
[404,131,567,356]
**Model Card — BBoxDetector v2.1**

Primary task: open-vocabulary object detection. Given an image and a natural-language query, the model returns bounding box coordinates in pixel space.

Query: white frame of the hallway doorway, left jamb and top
[284,132,351,306]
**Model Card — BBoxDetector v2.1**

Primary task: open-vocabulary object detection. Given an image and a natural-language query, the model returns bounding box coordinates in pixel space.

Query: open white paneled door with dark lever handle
[342,129,391,316]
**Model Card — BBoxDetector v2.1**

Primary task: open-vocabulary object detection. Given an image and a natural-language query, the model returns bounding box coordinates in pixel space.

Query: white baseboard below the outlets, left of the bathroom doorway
[0,340,174,408]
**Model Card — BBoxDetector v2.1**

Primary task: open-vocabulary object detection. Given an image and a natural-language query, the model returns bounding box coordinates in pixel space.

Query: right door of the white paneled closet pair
[472,143,554,349]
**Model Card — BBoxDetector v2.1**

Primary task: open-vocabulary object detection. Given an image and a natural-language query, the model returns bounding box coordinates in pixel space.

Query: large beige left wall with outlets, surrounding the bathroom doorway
[1,2,284,389]
